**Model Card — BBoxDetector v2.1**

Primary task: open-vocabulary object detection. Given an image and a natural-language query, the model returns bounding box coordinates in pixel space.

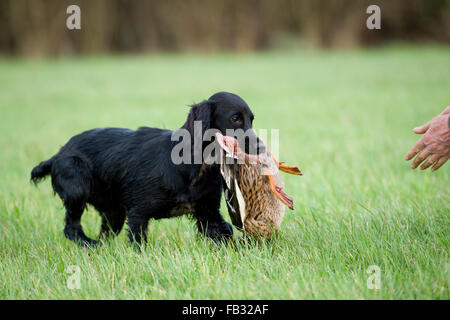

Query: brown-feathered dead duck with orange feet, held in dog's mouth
[216,133,302,239]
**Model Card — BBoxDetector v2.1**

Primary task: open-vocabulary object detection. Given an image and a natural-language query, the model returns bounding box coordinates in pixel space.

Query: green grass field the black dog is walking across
[0,47,450,299]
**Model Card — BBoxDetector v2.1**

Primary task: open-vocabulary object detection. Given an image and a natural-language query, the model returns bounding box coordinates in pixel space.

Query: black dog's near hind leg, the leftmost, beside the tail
[51,156,97,247]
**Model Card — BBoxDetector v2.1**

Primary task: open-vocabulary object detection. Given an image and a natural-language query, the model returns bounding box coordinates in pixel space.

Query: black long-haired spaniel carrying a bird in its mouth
[31,92,263,246]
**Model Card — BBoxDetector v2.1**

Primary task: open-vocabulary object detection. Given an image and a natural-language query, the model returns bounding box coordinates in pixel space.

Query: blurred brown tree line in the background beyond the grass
[0,0,450,56]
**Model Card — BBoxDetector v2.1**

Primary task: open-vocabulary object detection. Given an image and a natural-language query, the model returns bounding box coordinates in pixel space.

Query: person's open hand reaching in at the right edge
[405,106,450,171]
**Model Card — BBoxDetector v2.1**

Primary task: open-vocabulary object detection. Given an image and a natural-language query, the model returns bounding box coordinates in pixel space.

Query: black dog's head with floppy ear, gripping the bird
[184,92,266,154]
